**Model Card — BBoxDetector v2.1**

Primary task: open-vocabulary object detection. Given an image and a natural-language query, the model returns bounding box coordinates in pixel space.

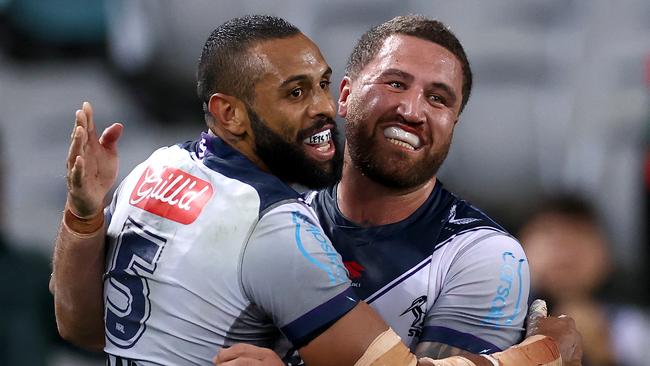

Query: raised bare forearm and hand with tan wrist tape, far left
[50,103,122,350]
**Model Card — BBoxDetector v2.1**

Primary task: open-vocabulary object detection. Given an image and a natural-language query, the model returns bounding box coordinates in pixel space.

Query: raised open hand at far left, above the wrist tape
[66,102,124,218]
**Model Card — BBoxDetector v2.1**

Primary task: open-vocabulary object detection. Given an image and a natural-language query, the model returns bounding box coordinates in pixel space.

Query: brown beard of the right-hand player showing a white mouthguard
[345,108,452,190]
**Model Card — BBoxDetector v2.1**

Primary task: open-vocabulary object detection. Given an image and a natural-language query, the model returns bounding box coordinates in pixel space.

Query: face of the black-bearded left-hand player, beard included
[248,34,342,188]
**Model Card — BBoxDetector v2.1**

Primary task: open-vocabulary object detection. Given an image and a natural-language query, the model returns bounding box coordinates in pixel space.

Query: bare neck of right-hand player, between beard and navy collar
[336,161,436,226]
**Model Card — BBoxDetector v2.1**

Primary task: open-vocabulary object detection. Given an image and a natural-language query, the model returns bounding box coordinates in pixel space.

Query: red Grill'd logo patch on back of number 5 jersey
[129,167,213,225]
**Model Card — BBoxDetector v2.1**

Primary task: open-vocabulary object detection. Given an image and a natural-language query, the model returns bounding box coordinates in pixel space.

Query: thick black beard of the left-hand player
[246,106,343,189]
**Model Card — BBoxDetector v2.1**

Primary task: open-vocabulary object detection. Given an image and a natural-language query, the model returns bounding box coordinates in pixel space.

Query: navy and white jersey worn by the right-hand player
[312,182,530,353]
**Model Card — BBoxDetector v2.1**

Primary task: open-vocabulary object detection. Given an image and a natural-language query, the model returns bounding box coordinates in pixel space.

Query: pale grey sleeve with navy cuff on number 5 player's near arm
[241,203,359,348]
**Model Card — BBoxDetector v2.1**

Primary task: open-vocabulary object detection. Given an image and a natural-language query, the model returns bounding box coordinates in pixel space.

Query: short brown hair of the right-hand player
[345,15,472,111]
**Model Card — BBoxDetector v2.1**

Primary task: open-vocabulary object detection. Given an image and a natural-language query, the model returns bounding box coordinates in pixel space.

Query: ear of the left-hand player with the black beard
[208,93,249,136]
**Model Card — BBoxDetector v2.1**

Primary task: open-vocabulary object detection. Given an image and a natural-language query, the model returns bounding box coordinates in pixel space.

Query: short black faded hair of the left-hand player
[196,15,300,110]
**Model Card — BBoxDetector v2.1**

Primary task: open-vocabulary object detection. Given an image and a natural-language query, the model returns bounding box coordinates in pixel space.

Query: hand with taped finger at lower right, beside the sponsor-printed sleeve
[526,300,582,366]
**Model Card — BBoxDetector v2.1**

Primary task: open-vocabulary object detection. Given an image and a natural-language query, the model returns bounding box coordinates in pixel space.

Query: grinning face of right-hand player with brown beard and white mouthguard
[339,35,463,188]
